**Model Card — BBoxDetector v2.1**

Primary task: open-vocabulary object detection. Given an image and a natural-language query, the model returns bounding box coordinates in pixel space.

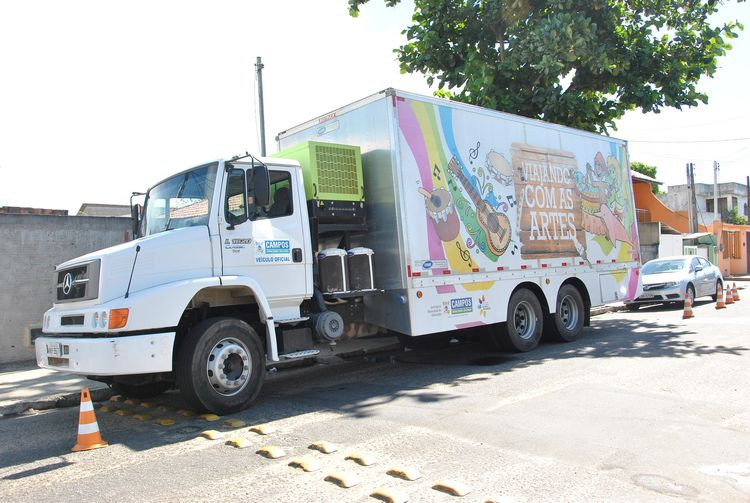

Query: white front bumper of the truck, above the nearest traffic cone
[34,332,175,376]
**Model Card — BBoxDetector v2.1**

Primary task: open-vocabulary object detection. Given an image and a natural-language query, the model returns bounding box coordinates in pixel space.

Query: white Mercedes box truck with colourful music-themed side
[36,89,641,414]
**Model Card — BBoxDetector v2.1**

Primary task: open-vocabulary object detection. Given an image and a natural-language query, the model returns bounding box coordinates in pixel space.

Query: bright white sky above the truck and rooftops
[0,0,750,213]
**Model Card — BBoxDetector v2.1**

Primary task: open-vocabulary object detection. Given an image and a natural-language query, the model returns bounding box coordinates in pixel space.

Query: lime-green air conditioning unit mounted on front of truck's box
[273,141,365,223]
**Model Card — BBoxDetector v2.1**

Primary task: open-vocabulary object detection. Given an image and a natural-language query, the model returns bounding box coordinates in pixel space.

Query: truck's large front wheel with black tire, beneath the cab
[176,318,266,415]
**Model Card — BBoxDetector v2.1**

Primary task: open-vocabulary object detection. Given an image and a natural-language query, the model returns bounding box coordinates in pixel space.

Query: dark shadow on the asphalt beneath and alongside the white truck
[0,317,750,472]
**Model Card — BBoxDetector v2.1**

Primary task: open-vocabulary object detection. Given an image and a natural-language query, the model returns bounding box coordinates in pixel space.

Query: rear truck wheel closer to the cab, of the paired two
[488,288,544,353]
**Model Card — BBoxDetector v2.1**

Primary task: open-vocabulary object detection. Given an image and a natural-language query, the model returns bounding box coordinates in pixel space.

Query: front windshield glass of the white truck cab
[141,163,217,236]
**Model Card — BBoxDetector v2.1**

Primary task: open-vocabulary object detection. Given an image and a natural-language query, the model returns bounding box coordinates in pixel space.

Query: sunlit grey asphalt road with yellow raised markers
[0,300,750,502]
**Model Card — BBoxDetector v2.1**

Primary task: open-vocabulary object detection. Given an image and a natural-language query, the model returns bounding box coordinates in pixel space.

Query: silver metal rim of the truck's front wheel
[206,337,253,396]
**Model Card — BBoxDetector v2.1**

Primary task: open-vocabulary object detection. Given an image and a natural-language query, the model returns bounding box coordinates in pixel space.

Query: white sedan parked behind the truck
[625,255,724,311]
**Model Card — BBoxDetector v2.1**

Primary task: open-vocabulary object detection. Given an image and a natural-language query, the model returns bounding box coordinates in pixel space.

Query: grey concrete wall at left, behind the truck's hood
[0,215,131,363]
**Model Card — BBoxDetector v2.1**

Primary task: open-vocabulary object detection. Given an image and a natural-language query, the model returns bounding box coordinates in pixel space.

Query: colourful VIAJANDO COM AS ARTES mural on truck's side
[397,98,638,304]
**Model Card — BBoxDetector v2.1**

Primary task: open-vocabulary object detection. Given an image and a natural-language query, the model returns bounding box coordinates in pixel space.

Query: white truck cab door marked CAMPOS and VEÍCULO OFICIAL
[221,167,309,318]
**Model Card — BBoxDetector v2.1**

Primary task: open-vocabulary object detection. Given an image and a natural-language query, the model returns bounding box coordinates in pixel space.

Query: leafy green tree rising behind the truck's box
[348,0,744,132]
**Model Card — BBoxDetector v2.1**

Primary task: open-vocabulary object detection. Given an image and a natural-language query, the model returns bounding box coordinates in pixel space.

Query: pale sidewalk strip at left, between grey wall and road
[0,362,111,416]
